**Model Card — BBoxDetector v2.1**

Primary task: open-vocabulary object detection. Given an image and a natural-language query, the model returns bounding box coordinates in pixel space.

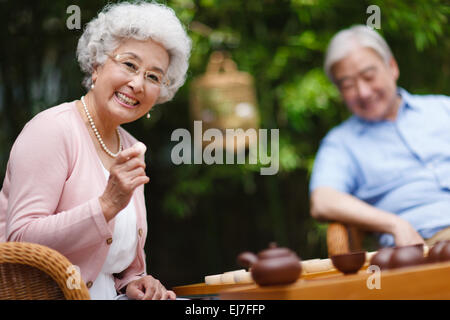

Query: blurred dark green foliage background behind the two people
[0,0,450,287]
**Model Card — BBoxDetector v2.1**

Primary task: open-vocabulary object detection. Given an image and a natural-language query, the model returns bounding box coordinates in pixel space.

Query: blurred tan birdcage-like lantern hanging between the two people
[190,52,259,151]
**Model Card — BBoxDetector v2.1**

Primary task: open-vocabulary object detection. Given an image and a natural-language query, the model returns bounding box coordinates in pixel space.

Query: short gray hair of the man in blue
[324,25,393,81]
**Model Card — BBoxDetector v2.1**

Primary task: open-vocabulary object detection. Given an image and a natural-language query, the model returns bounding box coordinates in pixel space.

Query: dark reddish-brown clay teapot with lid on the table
[237,243,302,286]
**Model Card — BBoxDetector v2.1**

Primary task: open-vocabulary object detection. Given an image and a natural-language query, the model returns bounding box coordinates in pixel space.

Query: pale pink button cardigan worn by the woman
[0,102,147,290]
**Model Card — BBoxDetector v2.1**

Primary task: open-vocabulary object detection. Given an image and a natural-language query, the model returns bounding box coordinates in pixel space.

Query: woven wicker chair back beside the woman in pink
[0,242,90,300]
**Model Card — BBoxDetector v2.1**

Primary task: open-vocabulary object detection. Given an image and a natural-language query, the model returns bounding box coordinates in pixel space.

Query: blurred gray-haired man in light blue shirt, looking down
[310,26,450,246]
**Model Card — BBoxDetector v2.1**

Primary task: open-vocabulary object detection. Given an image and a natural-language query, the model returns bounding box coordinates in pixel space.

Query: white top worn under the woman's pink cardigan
[89,165,137,300]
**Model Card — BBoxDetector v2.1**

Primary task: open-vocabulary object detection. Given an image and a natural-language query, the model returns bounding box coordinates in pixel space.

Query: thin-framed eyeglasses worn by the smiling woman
[108,54,170,87]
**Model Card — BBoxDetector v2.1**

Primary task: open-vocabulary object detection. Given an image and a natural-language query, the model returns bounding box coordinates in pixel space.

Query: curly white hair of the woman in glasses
[77,1,191,103]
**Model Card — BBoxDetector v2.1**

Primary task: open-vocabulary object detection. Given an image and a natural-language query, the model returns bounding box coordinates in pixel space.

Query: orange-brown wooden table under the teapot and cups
[173,262,450,300]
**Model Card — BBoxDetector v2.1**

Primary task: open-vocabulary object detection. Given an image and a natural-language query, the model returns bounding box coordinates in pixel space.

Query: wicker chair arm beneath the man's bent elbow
[327,222,366,257]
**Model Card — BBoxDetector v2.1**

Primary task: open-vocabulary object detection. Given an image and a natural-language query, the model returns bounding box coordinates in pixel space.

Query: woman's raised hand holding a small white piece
[99,142,150,221]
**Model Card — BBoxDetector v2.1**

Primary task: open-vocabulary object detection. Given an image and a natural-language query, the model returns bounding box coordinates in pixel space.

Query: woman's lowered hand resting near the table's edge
[126,275,177,300]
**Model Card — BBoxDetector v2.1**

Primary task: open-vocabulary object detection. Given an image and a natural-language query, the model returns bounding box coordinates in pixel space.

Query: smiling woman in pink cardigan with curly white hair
[0,2,191,299]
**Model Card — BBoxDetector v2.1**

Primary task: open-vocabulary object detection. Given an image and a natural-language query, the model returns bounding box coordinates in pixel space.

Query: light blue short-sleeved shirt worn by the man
[310,89,450,246]
